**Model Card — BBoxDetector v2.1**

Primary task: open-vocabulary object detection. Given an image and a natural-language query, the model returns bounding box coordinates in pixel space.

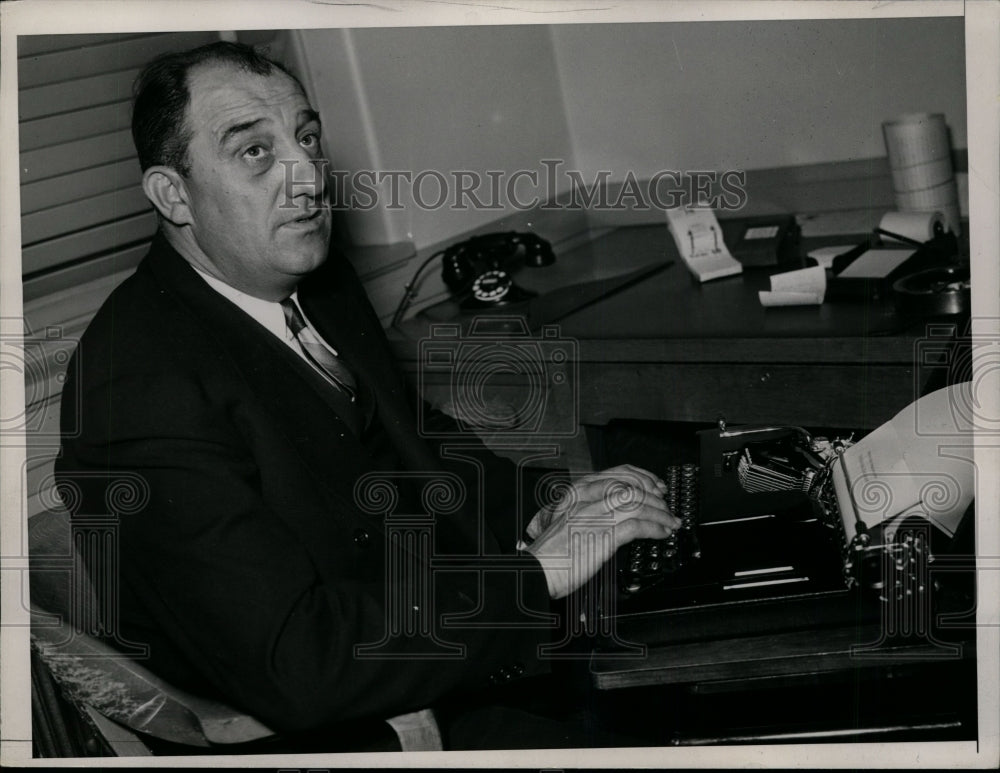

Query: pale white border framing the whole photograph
[0,0,1000,769]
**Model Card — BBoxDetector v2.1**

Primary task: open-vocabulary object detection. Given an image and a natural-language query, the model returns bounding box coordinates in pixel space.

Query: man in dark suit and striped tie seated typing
[57,43,678,745]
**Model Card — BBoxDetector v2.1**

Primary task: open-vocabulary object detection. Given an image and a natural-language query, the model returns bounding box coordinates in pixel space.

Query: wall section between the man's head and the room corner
[290,26,571,247]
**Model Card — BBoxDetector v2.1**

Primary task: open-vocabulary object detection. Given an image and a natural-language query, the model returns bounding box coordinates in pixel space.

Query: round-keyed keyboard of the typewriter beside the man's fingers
[616,464,701,595]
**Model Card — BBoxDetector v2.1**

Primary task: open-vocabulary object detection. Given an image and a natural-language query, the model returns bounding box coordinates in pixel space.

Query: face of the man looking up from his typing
[172,65,330,300]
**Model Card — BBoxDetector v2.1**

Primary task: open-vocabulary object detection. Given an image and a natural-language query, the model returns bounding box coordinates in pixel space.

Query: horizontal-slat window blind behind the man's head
[18,32,218,301]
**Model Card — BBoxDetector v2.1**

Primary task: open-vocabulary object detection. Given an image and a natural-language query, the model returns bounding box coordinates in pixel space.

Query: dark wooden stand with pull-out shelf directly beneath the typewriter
[590,624,977,746]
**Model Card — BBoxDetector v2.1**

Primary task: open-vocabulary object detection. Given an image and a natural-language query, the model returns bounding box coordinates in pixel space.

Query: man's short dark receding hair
[132,41,305,177]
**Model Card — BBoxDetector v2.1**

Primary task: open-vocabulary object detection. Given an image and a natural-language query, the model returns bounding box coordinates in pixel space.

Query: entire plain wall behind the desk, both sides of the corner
[290,18,966,248]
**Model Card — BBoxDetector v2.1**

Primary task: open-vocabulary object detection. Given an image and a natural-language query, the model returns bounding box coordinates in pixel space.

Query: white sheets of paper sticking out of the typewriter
[834,383,975,536]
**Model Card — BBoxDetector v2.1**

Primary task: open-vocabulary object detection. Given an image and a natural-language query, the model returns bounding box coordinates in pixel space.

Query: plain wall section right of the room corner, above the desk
[551,17,966,179]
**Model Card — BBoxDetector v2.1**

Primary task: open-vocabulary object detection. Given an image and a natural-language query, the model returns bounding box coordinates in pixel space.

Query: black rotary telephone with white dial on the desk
[441,231,555,309]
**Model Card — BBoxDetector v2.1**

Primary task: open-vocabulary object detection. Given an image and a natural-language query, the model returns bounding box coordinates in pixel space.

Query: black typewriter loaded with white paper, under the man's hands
[596,385,973,647]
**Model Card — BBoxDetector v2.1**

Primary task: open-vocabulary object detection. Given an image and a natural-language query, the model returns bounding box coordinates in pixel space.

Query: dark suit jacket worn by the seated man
[56,237,552,730]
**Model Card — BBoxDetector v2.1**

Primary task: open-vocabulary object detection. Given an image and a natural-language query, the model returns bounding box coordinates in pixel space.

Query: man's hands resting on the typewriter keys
[526,464,681,599]
